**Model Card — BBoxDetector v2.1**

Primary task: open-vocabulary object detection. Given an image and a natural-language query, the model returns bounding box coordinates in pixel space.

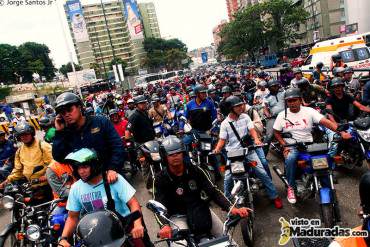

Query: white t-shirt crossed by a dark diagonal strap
[219,113,254,151]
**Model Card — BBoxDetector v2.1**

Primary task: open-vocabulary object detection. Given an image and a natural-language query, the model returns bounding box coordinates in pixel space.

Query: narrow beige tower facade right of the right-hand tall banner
[139,2,161,38]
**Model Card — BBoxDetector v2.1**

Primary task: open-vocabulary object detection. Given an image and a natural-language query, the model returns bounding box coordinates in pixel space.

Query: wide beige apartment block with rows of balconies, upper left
[65,0,145,74]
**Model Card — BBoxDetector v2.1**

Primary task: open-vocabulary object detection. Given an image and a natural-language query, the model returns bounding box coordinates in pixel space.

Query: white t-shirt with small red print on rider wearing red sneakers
[273,106,324,143]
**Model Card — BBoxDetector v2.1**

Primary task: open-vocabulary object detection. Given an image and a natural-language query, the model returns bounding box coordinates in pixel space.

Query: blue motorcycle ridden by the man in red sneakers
[273,137,341,228]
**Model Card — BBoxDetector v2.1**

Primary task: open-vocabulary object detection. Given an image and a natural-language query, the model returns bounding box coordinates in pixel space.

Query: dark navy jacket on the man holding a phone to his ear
[53,116,124,171]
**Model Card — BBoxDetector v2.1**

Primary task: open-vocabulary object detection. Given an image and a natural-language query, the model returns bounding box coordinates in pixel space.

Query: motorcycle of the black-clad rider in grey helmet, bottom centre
[147,200,241,247]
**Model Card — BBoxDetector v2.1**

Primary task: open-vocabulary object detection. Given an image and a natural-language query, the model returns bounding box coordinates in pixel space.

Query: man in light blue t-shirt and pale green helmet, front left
[59,148,150,247]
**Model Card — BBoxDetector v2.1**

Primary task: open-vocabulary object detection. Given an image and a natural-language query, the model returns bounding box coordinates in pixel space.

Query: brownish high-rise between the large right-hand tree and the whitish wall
[296,0,346,44]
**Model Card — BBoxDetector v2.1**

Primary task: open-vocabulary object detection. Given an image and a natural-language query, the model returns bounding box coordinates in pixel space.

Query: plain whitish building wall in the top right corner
[344,0,370,34]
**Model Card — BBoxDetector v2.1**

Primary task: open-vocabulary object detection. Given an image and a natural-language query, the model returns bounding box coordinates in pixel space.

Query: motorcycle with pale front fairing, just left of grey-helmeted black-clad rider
[139,140,162,189]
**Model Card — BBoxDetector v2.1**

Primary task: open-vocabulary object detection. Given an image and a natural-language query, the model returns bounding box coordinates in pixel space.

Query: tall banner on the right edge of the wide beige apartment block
[122,0,144,40]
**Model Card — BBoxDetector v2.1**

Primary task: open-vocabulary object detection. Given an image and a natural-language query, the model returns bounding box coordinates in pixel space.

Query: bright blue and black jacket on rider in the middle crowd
[185,98,217,131]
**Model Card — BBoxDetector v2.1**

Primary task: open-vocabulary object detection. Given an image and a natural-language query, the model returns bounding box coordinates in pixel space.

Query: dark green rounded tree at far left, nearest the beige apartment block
[18,42,56,82]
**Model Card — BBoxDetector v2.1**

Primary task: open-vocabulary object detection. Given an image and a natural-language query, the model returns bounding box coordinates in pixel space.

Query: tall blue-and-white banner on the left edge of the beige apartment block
[66,0,89,43]
